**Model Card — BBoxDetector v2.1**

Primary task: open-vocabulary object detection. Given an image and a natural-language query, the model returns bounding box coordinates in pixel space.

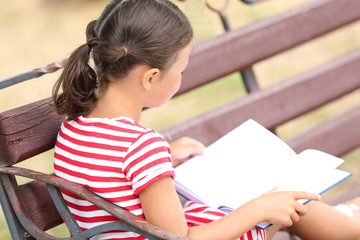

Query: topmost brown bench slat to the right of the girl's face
[178,0,360,94]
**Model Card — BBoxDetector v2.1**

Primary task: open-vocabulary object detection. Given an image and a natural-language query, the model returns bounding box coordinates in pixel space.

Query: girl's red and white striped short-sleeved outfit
[54,117,266,240]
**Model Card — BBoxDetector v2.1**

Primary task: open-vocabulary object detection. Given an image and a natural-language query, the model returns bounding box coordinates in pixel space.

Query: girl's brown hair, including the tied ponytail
[52,0,193,120]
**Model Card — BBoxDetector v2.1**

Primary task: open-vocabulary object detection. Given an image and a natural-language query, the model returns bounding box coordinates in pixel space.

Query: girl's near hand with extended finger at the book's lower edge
[255,191,320,227]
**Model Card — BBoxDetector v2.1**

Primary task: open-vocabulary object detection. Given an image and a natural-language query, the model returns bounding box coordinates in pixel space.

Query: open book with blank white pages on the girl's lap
[175,119,352,229]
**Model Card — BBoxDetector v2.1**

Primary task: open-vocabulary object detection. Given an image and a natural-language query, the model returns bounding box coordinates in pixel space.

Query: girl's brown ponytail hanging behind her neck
[52,21,98,121]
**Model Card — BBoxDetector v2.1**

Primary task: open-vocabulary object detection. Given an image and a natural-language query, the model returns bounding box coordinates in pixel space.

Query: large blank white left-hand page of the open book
[175,120,296,208]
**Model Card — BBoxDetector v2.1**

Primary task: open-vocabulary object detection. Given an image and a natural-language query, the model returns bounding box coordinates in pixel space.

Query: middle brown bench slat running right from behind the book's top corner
[161,49,360,144]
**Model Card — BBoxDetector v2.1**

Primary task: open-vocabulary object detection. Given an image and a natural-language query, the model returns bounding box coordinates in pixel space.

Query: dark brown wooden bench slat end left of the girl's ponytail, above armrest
[0,99,63,166]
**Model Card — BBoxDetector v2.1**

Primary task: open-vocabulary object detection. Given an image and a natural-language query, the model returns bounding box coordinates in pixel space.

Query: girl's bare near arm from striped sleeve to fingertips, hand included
[140,177,319,240]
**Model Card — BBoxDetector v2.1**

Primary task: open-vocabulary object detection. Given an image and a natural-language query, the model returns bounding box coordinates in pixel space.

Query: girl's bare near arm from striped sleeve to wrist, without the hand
[140,177,261,240]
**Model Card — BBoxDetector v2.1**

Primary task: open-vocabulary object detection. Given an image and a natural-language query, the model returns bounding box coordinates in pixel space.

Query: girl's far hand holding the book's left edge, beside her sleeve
[170,137,205,168]
